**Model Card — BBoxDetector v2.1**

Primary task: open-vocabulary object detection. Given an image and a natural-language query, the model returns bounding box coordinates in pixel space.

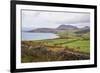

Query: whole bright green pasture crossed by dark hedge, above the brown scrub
[32,38,90,53]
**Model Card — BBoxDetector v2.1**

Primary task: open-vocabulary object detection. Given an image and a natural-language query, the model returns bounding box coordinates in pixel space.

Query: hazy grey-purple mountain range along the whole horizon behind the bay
[28,25,90,33]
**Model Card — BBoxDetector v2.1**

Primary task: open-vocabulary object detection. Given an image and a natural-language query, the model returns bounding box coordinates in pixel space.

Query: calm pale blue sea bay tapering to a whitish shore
[22,32,59,41]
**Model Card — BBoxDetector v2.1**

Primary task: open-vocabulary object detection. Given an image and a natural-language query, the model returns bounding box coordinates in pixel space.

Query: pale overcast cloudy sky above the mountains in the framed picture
[22,10,90,28]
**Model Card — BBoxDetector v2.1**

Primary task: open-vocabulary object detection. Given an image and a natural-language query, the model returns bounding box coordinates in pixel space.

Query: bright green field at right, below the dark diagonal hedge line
[63,40,90,53]
